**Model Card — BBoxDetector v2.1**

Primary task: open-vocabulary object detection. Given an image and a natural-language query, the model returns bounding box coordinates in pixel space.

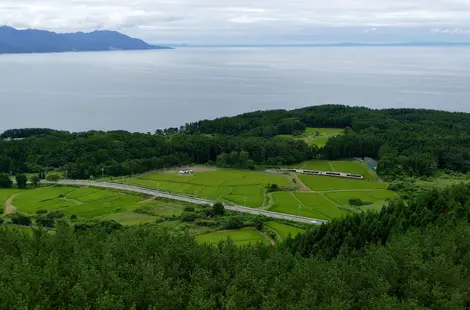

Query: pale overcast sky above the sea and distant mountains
[0,0,470,44]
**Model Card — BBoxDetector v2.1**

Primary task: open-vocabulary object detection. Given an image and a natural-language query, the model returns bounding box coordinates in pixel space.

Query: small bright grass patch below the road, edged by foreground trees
[196,228,269,245]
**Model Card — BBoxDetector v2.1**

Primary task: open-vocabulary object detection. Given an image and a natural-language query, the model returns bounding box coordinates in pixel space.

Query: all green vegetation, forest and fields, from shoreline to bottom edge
[0,105,470,310]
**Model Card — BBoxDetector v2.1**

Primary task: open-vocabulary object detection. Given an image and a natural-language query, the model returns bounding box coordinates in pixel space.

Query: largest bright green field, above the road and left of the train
[120,169,292,208]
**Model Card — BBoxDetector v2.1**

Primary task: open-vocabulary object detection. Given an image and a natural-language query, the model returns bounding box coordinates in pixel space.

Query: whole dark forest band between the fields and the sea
[0,105,470,179]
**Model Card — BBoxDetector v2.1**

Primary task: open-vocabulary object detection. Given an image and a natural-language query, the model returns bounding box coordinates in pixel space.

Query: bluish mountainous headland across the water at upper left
[0,26,171,54]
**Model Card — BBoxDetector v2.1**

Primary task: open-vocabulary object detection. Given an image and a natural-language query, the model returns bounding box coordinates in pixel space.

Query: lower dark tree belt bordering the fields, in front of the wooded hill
[0,131,314,178]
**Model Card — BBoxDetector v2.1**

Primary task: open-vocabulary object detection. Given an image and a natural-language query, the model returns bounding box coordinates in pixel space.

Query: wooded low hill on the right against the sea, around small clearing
[184,105,470,179]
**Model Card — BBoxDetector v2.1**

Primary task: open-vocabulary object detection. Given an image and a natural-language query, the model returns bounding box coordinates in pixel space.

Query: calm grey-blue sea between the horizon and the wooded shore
[0,47,470,131]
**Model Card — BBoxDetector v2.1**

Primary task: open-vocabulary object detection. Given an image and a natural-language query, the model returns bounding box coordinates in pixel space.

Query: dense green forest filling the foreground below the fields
[0,185,470,310]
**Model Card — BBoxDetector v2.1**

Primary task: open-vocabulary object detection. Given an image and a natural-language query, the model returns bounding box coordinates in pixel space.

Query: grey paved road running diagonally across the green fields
[52,180,327,225]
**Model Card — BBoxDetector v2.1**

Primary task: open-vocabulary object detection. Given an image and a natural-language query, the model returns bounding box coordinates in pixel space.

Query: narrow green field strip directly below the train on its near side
[299,174,387,191]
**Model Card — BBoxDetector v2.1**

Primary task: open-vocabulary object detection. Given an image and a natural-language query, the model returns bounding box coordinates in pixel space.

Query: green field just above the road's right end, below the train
[269,192,335,220]
